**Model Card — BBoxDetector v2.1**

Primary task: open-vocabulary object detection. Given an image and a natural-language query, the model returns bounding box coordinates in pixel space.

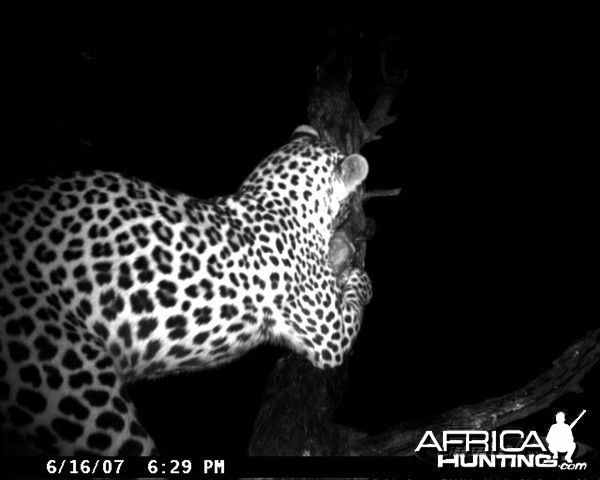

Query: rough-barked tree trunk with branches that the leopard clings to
[248,29,600,462]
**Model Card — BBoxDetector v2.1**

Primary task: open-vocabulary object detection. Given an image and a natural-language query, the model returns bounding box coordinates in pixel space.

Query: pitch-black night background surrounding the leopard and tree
[2,11,600,462]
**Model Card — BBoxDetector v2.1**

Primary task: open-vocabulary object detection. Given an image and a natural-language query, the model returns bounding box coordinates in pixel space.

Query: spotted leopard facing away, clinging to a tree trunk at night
[0,125,372,456]
